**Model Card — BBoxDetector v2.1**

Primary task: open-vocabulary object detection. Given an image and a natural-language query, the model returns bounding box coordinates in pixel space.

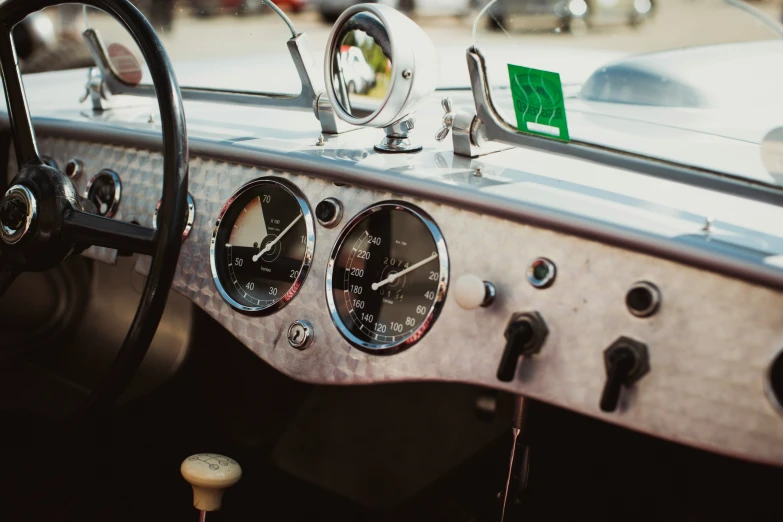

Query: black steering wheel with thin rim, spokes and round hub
[0,0,188,416]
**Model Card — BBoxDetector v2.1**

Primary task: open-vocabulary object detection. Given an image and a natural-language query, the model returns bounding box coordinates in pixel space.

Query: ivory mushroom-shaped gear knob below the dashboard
[180,453,242,511]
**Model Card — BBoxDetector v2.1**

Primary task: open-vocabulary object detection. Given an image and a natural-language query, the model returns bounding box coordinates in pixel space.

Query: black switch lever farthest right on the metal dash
[601,337,650,412]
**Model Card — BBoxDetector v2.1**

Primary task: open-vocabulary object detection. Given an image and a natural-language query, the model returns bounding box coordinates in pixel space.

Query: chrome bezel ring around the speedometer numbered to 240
[326,201,449,355]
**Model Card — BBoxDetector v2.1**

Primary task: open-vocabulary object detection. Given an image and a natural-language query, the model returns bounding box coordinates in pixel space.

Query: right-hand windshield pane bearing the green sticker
[473,0,783,182]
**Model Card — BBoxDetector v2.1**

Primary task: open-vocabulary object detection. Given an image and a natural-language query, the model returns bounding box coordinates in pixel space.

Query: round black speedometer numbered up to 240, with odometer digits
[326,201,449,353]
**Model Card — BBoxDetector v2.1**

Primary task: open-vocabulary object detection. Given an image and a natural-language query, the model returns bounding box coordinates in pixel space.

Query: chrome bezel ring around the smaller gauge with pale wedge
[209,177,315,316]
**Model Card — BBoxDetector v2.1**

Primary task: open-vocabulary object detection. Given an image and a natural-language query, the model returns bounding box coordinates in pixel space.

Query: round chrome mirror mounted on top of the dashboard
[324,4,438,128]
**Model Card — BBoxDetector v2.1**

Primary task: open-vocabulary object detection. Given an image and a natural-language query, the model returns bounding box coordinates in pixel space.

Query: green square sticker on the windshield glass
[508,64,569,141]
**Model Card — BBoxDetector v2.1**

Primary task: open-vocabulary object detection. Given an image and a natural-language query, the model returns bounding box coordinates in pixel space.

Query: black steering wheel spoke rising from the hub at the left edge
[0,26,41,170]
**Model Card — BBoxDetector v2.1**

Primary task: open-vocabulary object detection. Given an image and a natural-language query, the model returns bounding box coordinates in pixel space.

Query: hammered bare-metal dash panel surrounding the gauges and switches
[30,139,783,464]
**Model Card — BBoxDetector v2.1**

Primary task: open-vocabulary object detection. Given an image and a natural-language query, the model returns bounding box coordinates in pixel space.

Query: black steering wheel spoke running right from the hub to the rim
[63,210,155,255]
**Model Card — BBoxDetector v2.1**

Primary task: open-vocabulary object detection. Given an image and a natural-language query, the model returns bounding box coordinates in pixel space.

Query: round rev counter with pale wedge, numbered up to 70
[209,178,315,313]
